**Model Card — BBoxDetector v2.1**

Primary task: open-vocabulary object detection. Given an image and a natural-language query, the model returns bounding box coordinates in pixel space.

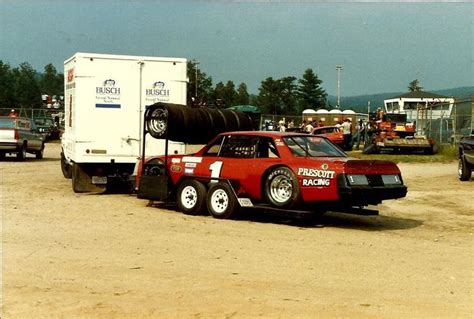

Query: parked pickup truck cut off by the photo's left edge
[0,116,44,160]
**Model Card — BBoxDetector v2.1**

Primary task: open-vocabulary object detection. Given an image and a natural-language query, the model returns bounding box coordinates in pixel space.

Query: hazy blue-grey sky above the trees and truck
[0,0,474,96]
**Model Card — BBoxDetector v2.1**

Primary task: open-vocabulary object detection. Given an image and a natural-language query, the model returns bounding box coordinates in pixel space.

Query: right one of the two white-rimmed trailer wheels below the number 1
[206,182,240,219]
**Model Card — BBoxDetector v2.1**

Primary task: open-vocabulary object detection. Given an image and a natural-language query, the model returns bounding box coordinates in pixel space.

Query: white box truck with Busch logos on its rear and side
[61,53,187,192]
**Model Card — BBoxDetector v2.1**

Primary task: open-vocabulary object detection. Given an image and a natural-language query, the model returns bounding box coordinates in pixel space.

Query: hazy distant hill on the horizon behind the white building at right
[328,86,474,112]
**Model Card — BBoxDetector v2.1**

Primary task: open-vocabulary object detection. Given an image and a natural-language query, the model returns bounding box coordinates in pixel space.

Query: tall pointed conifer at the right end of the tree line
[298,69,327,112]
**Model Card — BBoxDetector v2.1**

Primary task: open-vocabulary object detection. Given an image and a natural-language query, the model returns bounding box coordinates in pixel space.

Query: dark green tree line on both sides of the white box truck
[0,60,329,115]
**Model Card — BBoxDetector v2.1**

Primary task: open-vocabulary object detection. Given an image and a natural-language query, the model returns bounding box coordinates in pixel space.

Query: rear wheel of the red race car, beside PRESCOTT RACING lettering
[263,167,301,208]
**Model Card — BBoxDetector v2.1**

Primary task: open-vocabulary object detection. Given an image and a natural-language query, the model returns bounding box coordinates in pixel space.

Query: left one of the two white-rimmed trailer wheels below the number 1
[176,179,206,215]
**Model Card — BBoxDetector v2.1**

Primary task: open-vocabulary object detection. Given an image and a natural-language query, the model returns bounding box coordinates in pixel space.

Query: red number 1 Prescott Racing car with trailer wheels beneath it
[136,131,407,218]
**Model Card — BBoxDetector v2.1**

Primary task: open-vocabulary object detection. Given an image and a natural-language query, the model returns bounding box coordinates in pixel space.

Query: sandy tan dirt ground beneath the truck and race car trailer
[0,144,474,318]
